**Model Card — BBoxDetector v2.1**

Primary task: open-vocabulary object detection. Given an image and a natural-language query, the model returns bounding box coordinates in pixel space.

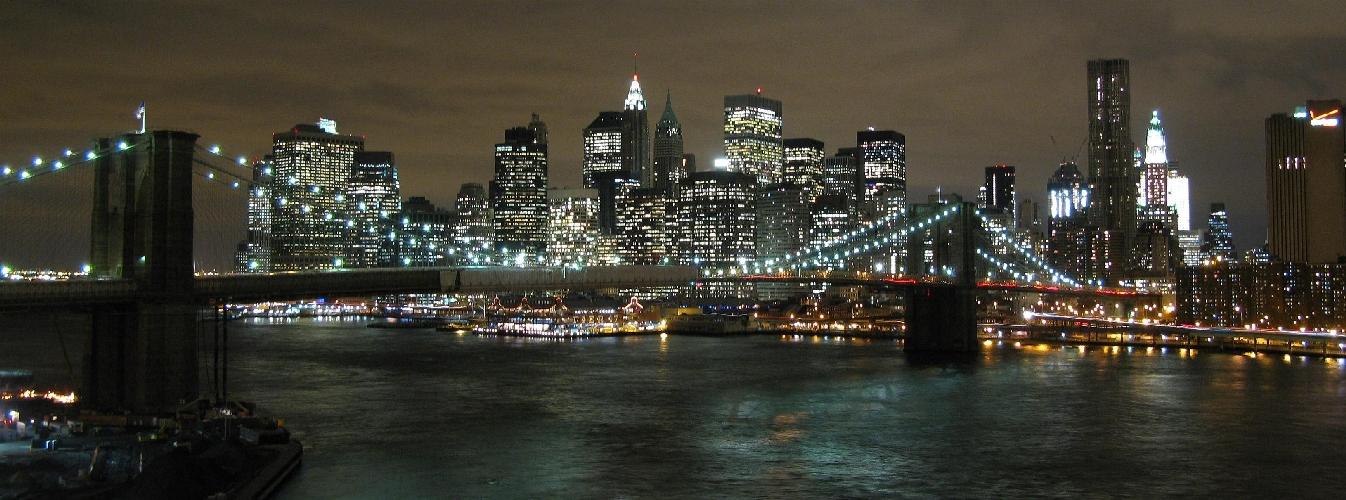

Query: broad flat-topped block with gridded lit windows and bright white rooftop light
[677,170,756,265]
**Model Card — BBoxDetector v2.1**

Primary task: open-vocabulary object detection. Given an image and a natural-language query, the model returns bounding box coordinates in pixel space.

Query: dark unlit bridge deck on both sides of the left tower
[0,265,699,310]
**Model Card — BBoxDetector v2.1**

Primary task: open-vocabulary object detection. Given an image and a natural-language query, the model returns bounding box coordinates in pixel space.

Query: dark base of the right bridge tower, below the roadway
[903,286,981,353]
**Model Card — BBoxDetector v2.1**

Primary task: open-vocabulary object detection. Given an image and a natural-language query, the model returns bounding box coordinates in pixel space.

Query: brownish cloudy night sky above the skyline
[0,1,1346,273]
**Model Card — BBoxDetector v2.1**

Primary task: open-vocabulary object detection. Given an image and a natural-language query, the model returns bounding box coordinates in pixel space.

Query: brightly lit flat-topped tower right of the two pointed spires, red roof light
[724,89,785,185]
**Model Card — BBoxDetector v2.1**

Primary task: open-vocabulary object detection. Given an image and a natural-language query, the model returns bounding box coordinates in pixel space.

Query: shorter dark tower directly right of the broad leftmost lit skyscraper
[345,151,402,268]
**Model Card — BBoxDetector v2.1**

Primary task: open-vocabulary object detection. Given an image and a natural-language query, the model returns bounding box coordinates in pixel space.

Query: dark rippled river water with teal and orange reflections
[209,321,1346,499]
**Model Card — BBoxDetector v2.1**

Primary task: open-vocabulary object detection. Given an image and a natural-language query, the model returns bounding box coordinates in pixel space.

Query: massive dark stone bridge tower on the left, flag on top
[81,131,199,412]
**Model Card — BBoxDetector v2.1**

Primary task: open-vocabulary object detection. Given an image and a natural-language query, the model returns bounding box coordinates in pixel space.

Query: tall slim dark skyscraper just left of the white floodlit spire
[1088,59,1140,284]
